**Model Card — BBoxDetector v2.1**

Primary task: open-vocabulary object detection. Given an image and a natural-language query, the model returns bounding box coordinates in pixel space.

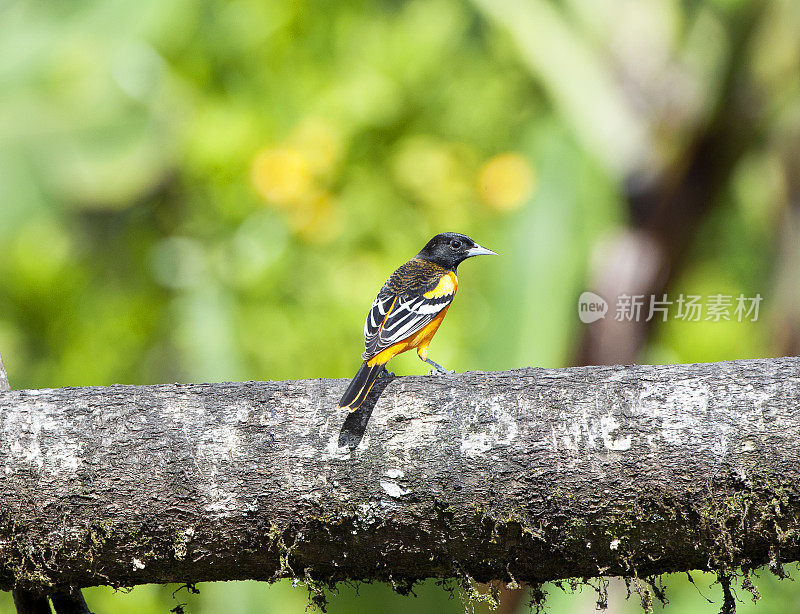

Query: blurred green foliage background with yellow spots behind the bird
[0,0,800,614]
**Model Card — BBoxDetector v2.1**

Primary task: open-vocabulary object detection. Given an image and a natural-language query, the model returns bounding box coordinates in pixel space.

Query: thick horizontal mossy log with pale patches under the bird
[0,358,800,590]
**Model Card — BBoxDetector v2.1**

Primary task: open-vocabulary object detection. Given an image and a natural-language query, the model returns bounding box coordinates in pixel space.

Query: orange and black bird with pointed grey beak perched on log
[339,232,497,412]
